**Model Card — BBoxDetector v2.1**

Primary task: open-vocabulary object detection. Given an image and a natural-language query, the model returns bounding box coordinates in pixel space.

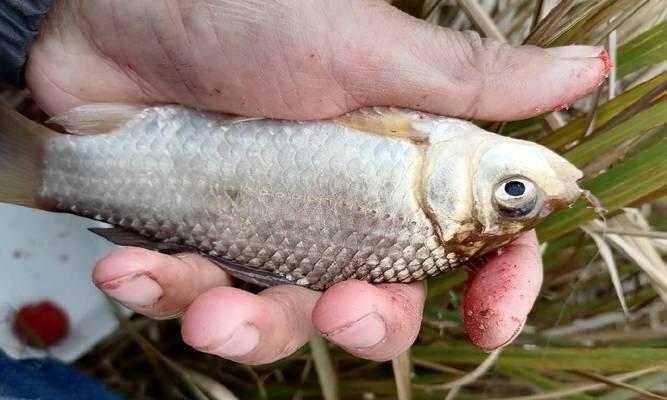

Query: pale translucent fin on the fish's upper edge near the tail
[47,103,146,135]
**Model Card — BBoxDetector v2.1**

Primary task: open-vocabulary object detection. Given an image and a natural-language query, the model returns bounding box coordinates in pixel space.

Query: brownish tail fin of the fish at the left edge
[0,105,57,208]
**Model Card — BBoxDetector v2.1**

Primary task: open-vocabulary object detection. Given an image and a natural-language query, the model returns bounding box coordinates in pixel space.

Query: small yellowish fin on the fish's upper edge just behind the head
[333,107,429,143]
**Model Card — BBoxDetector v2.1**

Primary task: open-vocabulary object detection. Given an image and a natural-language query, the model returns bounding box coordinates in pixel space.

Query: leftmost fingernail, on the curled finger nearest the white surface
[98,274,163,307]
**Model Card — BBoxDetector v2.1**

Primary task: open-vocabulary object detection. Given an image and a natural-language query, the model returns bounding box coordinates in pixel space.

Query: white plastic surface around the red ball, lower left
[0,204,130,362]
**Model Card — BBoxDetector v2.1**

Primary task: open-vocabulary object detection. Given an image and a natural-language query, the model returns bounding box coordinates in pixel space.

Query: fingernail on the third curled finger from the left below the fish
[325,312,387,349]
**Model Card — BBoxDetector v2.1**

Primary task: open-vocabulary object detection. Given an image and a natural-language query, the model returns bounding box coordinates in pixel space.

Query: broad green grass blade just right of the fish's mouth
[537,140,667,241]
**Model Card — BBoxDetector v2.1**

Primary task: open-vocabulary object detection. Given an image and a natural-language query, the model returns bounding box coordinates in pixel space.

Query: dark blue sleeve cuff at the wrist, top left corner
[0,0,51,87]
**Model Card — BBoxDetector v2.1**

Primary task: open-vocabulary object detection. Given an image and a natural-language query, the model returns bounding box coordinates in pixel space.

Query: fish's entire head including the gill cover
[423,119,583,257]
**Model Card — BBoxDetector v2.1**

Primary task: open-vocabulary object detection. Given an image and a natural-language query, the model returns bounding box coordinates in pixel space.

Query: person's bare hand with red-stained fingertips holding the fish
[26,0,606,363]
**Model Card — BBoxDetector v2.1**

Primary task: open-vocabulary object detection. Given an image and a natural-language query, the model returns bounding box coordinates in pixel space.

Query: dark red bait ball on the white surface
[14,301,69,347]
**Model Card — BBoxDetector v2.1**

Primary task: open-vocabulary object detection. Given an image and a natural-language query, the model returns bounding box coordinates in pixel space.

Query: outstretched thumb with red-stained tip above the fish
[341,6,611,120]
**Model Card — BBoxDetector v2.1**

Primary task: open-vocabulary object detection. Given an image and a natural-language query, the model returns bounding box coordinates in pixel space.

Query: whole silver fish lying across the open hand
[0,104,582,290]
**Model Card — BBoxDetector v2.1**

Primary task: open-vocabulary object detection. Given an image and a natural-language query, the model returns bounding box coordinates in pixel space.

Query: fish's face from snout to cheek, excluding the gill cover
[471,137,583,236]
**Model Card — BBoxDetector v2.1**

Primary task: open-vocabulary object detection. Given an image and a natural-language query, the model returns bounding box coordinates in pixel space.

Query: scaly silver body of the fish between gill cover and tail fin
[40,107,456,289]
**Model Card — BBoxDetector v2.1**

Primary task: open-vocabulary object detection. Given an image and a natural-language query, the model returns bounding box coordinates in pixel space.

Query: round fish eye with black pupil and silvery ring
[494,177,537,218]
